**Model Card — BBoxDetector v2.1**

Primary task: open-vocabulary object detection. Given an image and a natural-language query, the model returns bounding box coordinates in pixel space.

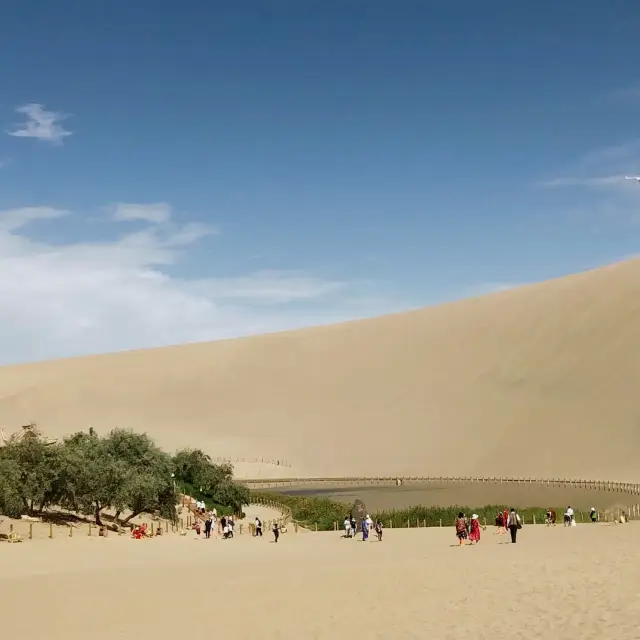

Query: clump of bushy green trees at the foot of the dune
[0,429,249,524]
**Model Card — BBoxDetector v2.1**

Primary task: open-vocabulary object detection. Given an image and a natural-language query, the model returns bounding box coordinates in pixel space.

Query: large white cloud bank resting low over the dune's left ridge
[0,206,364,364]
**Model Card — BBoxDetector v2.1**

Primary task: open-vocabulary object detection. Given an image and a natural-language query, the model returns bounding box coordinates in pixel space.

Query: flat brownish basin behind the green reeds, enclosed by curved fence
[265,484,640,512]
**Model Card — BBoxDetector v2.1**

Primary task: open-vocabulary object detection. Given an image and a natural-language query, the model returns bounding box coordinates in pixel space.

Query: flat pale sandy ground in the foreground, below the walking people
[0,523,640,640]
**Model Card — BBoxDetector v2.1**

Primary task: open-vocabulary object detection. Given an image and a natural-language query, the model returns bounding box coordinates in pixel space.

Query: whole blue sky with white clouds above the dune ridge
[0,0,640,362]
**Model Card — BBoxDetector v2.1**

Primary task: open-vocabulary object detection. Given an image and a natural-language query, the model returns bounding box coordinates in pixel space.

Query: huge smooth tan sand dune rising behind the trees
[0,260,640,481]
